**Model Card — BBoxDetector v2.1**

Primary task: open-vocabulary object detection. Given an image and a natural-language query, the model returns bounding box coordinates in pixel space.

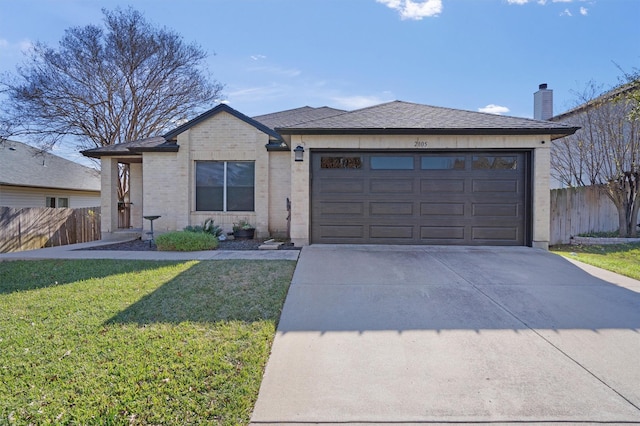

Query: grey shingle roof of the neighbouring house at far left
[0,140,100,191]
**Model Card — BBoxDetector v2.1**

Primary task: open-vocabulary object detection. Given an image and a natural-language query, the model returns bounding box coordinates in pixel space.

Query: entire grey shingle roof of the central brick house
[82,101,578,158]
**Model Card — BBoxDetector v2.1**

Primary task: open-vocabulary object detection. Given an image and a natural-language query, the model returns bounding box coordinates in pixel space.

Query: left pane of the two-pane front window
[196,161,224,211]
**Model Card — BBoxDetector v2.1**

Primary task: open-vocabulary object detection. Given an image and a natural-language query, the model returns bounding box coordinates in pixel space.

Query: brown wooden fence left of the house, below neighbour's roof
[0,207,100,253]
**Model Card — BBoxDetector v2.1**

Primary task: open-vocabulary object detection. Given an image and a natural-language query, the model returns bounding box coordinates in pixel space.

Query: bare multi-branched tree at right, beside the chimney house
[551,79,640,237]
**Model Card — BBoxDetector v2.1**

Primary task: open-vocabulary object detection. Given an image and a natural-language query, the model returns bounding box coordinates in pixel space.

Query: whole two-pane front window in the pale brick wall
[196,161,255,212]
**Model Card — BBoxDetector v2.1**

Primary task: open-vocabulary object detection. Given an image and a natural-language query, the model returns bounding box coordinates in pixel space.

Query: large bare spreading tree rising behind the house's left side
[0,8,222,197]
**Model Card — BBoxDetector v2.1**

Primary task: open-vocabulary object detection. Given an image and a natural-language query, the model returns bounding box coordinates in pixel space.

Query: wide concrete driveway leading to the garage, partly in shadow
[252,245,640,424]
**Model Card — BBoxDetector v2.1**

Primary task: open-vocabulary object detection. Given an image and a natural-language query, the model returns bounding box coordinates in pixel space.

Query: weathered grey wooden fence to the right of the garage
[549,186,619,245]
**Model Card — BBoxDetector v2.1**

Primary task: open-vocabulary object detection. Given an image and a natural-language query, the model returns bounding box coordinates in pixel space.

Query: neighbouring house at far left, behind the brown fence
[0,140,100,208]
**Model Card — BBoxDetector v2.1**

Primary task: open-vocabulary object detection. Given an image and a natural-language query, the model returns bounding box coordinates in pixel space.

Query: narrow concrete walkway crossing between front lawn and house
[0,241,300,262]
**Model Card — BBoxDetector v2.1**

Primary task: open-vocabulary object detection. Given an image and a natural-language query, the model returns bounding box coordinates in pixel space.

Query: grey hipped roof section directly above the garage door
[275,101,578,139]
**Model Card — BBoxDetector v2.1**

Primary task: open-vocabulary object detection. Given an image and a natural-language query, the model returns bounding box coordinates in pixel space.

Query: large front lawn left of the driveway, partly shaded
[0,260,295,425]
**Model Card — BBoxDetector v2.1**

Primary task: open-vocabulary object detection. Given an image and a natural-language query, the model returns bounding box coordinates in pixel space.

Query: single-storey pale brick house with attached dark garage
[83,101,576,248]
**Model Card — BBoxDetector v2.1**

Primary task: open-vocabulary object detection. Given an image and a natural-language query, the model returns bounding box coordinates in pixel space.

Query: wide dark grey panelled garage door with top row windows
[311,152,530,245]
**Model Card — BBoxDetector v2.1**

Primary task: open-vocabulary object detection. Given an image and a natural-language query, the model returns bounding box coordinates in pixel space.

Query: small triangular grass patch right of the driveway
[551,243,640,280]
